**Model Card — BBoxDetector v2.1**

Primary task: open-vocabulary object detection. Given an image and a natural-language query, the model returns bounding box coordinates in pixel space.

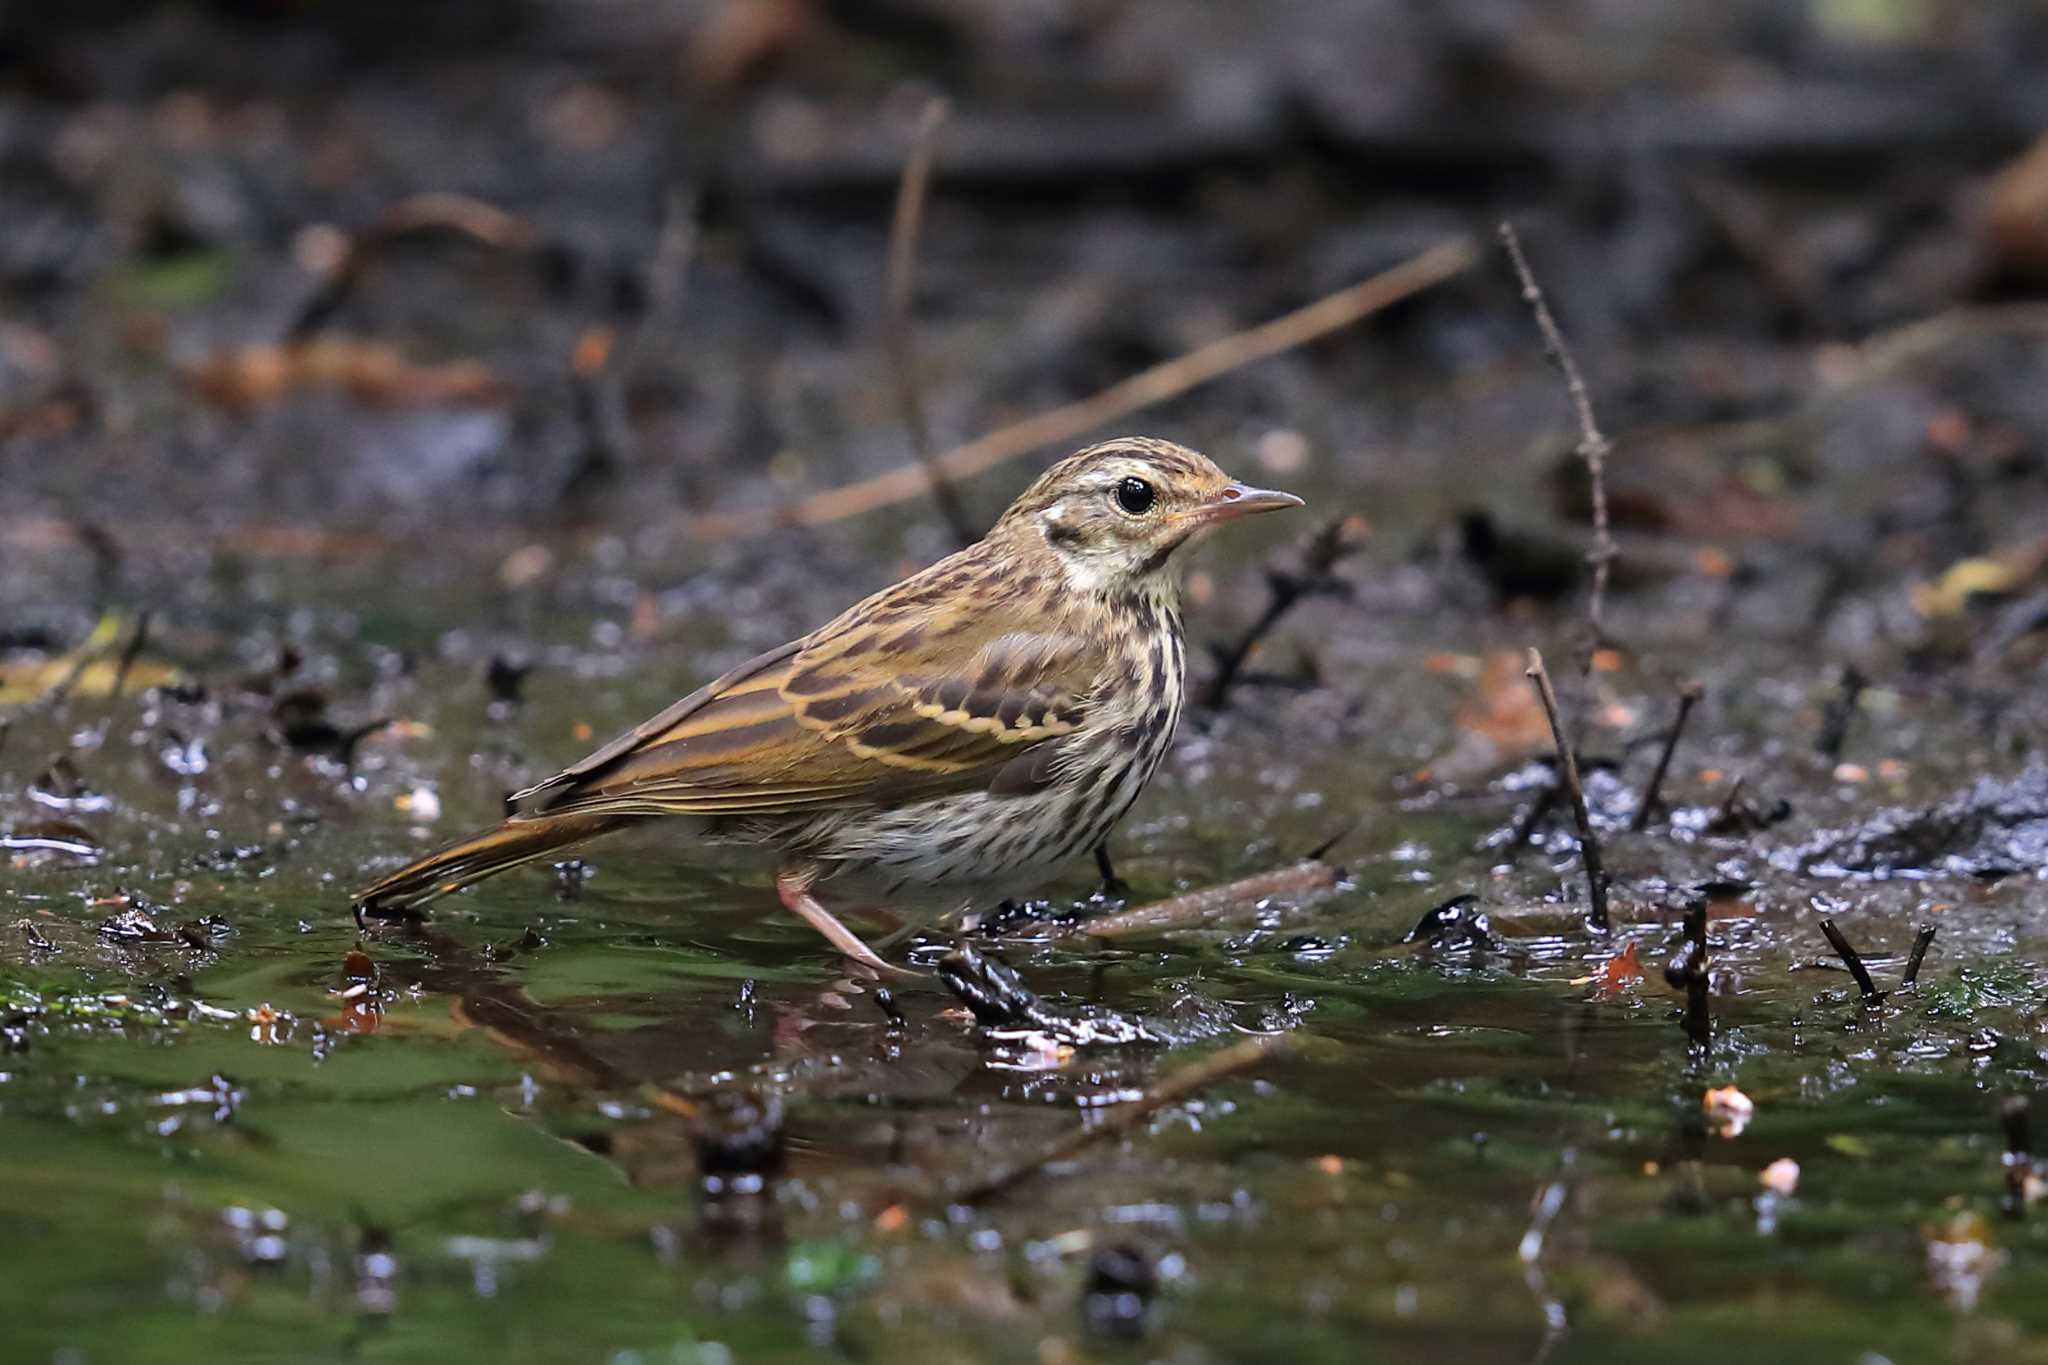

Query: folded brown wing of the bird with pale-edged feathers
[522,612,1104,814]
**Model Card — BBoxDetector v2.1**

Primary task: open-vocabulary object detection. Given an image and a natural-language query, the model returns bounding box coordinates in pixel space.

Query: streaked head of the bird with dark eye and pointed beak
[995,436,1300,589]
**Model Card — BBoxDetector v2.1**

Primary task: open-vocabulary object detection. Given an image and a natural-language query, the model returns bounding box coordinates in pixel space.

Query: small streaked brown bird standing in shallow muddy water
[354,436,1303,972]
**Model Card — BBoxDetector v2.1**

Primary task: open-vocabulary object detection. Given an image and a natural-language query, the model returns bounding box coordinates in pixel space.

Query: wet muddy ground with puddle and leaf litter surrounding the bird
[0,0,2048,1365]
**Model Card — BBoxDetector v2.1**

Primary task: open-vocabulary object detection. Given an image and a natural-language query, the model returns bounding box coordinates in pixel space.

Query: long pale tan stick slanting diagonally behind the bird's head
[688,237,1477,540]
